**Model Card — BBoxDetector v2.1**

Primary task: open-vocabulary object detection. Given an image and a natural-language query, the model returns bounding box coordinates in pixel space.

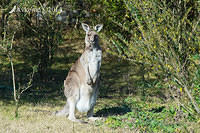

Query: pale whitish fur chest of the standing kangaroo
[88,49,102,77]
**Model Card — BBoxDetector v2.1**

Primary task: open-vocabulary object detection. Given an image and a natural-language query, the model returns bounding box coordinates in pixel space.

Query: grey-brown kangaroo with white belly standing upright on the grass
[56,23,103,122]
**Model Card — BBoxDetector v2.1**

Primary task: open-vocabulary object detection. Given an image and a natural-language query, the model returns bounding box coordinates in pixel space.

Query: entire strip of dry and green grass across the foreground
[0,94,200,133]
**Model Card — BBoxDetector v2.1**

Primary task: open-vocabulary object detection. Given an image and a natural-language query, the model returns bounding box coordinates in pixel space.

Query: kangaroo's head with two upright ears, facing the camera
[82,23,103,47]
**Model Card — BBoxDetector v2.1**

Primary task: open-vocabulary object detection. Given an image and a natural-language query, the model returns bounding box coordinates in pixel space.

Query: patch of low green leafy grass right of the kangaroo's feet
[105,97,200,133]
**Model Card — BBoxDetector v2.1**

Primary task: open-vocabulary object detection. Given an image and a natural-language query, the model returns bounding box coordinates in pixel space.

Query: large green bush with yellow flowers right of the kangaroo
[103,0,200,113]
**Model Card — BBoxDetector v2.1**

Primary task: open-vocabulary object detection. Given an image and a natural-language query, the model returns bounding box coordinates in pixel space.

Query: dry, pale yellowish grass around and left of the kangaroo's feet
[0,96,135,133]
